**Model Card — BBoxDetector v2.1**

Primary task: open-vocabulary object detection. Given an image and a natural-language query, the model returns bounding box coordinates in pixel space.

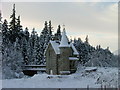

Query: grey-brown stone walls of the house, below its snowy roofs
[46,44,76,75]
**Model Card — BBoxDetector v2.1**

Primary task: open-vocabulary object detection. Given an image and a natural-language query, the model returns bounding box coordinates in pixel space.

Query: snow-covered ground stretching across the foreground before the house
[2,67,118,88]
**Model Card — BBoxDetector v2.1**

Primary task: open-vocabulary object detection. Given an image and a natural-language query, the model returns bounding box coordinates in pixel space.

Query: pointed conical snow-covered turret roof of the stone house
[59,29,69,47]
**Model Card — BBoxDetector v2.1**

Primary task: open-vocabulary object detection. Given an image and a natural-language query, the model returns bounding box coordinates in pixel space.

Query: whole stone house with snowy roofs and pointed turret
[45,29,79,75]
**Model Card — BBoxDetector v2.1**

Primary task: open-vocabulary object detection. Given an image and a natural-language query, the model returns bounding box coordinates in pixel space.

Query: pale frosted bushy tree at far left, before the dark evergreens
[2,39,23,78]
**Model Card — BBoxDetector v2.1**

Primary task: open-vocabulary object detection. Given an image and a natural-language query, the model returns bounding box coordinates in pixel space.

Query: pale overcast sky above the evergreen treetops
[2,2,118,51]
